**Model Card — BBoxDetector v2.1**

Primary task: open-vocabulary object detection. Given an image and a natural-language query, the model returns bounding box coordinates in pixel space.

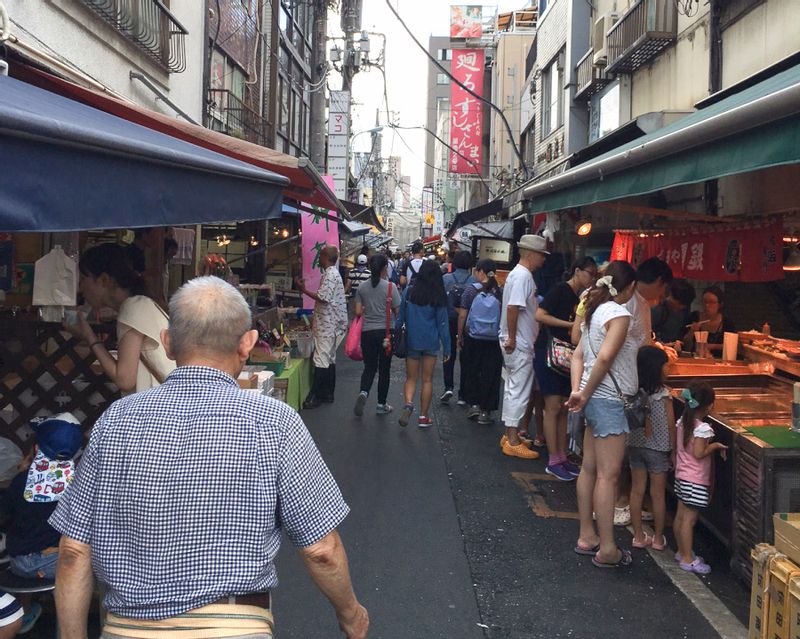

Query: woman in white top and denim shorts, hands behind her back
[567,261,639,568]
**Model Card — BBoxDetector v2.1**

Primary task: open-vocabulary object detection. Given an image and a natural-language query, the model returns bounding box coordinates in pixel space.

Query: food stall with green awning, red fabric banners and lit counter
[523,57,800,579]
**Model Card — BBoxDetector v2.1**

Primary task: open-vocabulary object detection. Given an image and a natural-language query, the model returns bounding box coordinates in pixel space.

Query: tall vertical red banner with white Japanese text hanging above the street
[448,49,484,174]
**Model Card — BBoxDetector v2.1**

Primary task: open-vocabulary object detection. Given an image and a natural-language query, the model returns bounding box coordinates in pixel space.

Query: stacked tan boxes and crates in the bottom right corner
[749,513,800,639]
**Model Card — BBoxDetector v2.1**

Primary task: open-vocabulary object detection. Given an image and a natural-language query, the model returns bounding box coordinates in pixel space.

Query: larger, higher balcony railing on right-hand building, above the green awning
[606,0,678,73]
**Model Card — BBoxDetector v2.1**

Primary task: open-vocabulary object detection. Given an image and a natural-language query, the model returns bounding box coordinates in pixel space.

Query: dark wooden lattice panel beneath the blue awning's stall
[0,317,119,451]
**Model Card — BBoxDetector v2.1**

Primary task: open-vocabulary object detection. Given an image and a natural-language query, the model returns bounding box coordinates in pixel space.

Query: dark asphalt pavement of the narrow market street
[274,357,749,639]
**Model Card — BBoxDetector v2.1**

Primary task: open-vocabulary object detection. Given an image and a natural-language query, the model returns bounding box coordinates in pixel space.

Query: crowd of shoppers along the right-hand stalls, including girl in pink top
[344,235,730,574]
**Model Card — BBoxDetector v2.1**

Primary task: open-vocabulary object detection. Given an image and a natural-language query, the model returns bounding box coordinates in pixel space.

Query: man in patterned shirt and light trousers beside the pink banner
[295,246,347,409]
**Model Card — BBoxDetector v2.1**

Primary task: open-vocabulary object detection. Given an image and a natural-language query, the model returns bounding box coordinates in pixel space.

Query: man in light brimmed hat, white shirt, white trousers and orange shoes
[500,235,550,459]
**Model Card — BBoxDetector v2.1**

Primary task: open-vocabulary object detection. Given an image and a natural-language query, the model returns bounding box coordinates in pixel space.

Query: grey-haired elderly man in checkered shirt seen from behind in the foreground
[50,277,369,639]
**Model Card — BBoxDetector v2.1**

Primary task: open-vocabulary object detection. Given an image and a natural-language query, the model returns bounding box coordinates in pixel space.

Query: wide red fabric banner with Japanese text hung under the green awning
[611,221,784,282]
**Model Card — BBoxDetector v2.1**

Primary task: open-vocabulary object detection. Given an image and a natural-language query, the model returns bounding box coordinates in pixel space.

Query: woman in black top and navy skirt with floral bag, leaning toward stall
[533,257,597,481]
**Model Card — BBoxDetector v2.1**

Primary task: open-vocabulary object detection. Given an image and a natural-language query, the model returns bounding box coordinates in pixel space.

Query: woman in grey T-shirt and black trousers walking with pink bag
[353,253,400,417]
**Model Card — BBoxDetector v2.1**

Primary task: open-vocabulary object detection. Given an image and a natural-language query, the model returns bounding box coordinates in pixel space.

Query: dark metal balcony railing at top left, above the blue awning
[82,0,188,73]
